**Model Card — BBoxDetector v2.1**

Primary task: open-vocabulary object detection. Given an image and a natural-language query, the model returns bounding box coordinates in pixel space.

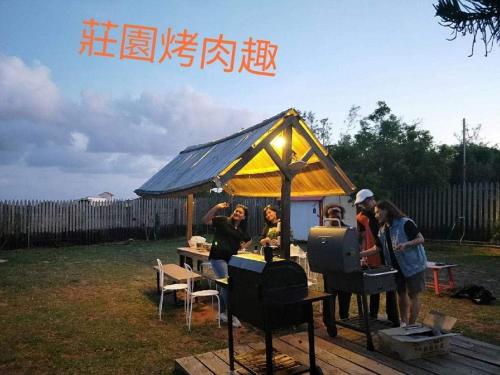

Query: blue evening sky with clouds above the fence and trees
[0,0,500,200]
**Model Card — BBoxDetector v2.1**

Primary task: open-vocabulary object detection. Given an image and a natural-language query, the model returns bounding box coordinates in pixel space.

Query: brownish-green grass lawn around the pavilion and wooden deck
[0,240,500,374]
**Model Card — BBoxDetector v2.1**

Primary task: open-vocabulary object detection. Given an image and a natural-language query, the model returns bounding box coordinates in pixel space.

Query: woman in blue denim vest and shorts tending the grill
[361,200,427,326]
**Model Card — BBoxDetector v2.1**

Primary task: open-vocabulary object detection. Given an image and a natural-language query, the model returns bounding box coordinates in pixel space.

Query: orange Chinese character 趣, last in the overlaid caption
[238,38,278,77]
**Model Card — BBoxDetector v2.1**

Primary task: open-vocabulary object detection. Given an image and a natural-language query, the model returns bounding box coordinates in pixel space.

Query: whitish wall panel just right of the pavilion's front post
[290,201,319,241]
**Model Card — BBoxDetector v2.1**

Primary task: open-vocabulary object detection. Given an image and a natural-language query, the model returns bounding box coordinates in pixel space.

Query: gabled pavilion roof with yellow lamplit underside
[135,109,354,197]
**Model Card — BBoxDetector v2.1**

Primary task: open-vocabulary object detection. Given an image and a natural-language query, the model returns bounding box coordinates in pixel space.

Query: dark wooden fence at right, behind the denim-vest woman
[393,182,500,241]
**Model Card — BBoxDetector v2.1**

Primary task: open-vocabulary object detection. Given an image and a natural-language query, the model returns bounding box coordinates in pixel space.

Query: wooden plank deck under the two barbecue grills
[175,327,500,375]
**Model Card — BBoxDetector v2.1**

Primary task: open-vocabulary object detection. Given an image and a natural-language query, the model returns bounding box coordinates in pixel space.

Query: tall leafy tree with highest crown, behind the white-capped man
[329,101,453,197]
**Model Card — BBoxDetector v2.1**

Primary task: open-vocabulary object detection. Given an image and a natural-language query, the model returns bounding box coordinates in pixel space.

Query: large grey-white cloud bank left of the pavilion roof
[0,56,262,185]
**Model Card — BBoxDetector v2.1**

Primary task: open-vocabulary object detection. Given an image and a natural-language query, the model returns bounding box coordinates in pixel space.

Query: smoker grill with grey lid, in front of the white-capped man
[307,227,398,350]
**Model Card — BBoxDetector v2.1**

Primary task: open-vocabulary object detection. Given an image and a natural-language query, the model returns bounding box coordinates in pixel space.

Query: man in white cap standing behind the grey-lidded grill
[354,189,399,325]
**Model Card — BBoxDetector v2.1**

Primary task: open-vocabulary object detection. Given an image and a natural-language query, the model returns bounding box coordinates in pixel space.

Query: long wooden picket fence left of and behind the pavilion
[0,194,275,249]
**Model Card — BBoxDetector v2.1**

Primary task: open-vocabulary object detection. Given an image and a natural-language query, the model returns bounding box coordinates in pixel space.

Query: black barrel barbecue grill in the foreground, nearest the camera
[228,254,330,374]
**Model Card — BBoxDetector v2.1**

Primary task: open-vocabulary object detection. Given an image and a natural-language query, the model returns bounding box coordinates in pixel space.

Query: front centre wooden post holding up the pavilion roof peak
[280,126,293,259]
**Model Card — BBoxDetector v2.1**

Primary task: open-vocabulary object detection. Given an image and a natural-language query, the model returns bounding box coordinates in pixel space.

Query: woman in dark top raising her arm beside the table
[202,202,252,327]
